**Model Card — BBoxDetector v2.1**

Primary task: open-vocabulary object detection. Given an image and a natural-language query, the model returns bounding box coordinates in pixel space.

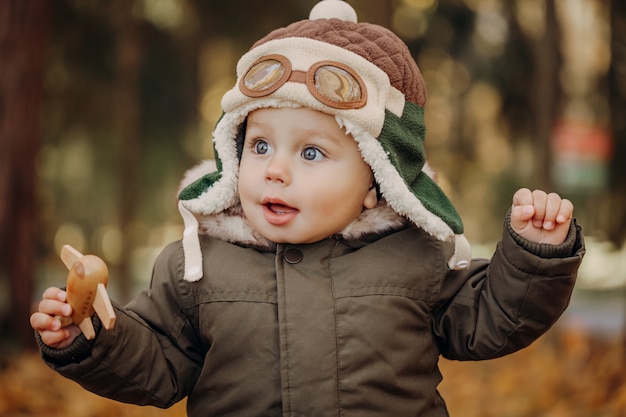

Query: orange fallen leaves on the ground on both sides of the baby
[0,329,626,417]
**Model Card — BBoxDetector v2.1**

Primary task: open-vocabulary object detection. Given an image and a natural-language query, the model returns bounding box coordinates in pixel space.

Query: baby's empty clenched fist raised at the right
[511,188,574,245]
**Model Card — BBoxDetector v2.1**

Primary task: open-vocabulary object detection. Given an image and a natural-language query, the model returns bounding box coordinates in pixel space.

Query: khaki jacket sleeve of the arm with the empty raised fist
[433,216,585,360]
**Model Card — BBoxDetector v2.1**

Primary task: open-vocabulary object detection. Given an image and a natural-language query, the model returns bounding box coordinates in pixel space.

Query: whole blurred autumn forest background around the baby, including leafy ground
[0,0,626,417]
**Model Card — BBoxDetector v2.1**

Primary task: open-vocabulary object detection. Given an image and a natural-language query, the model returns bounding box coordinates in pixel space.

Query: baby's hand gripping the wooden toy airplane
[30,287,80,348]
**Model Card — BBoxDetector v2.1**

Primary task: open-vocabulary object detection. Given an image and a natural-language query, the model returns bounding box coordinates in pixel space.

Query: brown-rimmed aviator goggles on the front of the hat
[239,54,367,109]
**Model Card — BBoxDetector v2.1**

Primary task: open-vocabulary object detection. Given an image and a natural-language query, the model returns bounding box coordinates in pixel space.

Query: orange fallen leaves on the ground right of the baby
[440,329,626,417]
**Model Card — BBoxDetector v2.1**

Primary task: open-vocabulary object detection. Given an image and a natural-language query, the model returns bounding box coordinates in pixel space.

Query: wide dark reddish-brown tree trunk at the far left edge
[0,0,49,346]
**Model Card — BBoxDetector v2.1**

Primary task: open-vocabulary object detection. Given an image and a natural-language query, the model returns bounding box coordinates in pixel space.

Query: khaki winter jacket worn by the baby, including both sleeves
[42,216,584,417]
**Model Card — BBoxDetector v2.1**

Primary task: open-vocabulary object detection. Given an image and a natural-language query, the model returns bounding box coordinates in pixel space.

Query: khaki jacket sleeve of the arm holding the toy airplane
[40,243,202,408]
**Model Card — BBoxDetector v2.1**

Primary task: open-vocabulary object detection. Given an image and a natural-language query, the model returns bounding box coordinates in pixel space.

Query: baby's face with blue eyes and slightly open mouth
[239,108,377,243]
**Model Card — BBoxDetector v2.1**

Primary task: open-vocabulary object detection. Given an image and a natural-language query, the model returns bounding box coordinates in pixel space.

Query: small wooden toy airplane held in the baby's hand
[61,245,115,340]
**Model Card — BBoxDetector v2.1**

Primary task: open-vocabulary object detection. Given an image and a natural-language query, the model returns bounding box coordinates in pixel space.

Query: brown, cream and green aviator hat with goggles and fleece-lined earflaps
[179,0,470,281]
